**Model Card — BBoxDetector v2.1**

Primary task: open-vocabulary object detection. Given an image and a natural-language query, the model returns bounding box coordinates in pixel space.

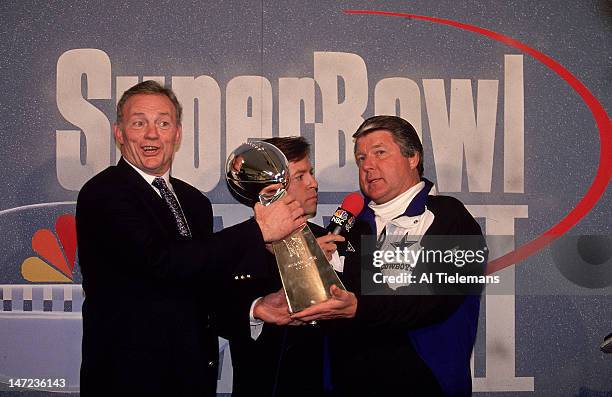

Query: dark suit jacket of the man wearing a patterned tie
[76,159,264,397]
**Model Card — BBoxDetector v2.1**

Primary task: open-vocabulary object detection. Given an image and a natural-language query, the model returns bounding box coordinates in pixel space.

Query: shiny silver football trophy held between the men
[225,141,345,313]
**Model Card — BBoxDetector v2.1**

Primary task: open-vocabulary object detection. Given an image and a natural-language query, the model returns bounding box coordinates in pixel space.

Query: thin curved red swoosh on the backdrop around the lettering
[344,10,612,274]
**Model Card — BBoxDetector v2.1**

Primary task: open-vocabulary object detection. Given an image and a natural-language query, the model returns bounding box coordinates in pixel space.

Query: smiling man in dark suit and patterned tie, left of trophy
[76,81,304,397]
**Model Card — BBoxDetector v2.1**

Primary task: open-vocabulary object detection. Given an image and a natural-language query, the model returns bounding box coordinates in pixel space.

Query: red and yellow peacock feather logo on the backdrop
[21,214,77,283]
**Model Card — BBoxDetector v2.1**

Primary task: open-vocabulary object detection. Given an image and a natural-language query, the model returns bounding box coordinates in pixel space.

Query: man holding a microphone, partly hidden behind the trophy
[230,137,344,397]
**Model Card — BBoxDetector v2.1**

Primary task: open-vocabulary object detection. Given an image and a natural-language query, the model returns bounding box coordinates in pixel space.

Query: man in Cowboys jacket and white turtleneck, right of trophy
[292,116,486,396]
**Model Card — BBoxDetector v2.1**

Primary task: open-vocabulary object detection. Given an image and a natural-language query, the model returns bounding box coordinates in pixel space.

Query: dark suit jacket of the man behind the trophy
[230,223,327,397]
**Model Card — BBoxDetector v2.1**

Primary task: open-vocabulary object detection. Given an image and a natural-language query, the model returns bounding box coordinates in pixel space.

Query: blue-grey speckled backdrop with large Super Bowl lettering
[0,0,612,396]
